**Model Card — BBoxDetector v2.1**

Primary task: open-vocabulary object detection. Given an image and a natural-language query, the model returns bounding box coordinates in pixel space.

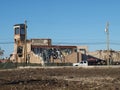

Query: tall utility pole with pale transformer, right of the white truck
[105,22,110,65]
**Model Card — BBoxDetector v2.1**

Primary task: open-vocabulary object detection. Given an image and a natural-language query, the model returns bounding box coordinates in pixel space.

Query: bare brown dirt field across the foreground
[0,67,120,90]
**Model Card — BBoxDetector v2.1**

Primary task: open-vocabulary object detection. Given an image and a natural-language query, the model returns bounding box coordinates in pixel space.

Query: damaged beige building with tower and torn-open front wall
[10,24,88,64]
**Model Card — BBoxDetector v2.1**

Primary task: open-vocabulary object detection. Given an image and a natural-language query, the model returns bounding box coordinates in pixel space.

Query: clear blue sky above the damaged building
[0,0,120,56]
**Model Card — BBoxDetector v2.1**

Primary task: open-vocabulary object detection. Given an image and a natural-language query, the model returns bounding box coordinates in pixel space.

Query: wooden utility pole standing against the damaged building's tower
[24,20,27,64]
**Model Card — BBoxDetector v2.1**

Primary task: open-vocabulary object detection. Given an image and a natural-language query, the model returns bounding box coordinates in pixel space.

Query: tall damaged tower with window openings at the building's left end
[14,22,27,63]
